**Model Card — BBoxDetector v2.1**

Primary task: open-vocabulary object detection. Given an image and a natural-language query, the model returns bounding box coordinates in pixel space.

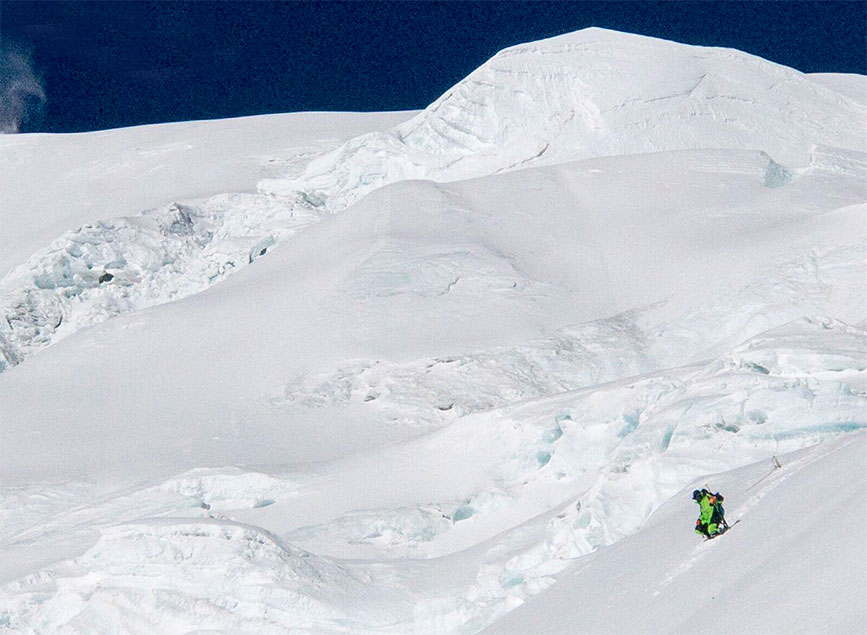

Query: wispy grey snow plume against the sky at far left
[0,44,45,134]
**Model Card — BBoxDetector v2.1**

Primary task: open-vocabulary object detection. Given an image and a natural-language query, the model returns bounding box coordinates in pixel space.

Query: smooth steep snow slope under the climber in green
[485,434,867,634]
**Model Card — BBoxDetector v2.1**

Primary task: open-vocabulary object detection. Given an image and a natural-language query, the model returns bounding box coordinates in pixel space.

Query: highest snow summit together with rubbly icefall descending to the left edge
[0,29,865,371]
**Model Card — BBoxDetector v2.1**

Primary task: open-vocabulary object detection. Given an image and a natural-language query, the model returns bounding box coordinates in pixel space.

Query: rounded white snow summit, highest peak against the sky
[259,28,867,212]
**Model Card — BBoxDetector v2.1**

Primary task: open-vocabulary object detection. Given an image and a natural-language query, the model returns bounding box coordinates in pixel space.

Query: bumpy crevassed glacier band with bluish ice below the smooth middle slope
[0,322,867,633]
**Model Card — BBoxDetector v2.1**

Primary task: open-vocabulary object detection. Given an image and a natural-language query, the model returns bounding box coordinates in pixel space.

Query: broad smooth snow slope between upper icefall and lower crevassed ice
[0,152,865,483]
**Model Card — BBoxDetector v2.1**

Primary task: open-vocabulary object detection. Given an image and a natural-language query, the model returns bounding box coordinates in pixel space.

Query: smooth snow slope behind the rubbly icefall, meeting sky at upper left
[0,113,414,275]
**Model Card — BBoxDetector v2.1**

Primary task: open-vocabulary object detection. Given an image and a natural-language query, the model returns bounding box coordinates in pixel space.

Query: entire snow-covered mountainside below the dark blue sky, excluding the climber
[0,29,867,633]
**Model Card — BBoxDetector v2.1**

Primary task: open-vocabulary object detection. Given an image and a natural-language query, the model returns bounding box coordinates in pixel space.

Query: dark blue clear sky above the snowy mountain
[0,0,867,132]
